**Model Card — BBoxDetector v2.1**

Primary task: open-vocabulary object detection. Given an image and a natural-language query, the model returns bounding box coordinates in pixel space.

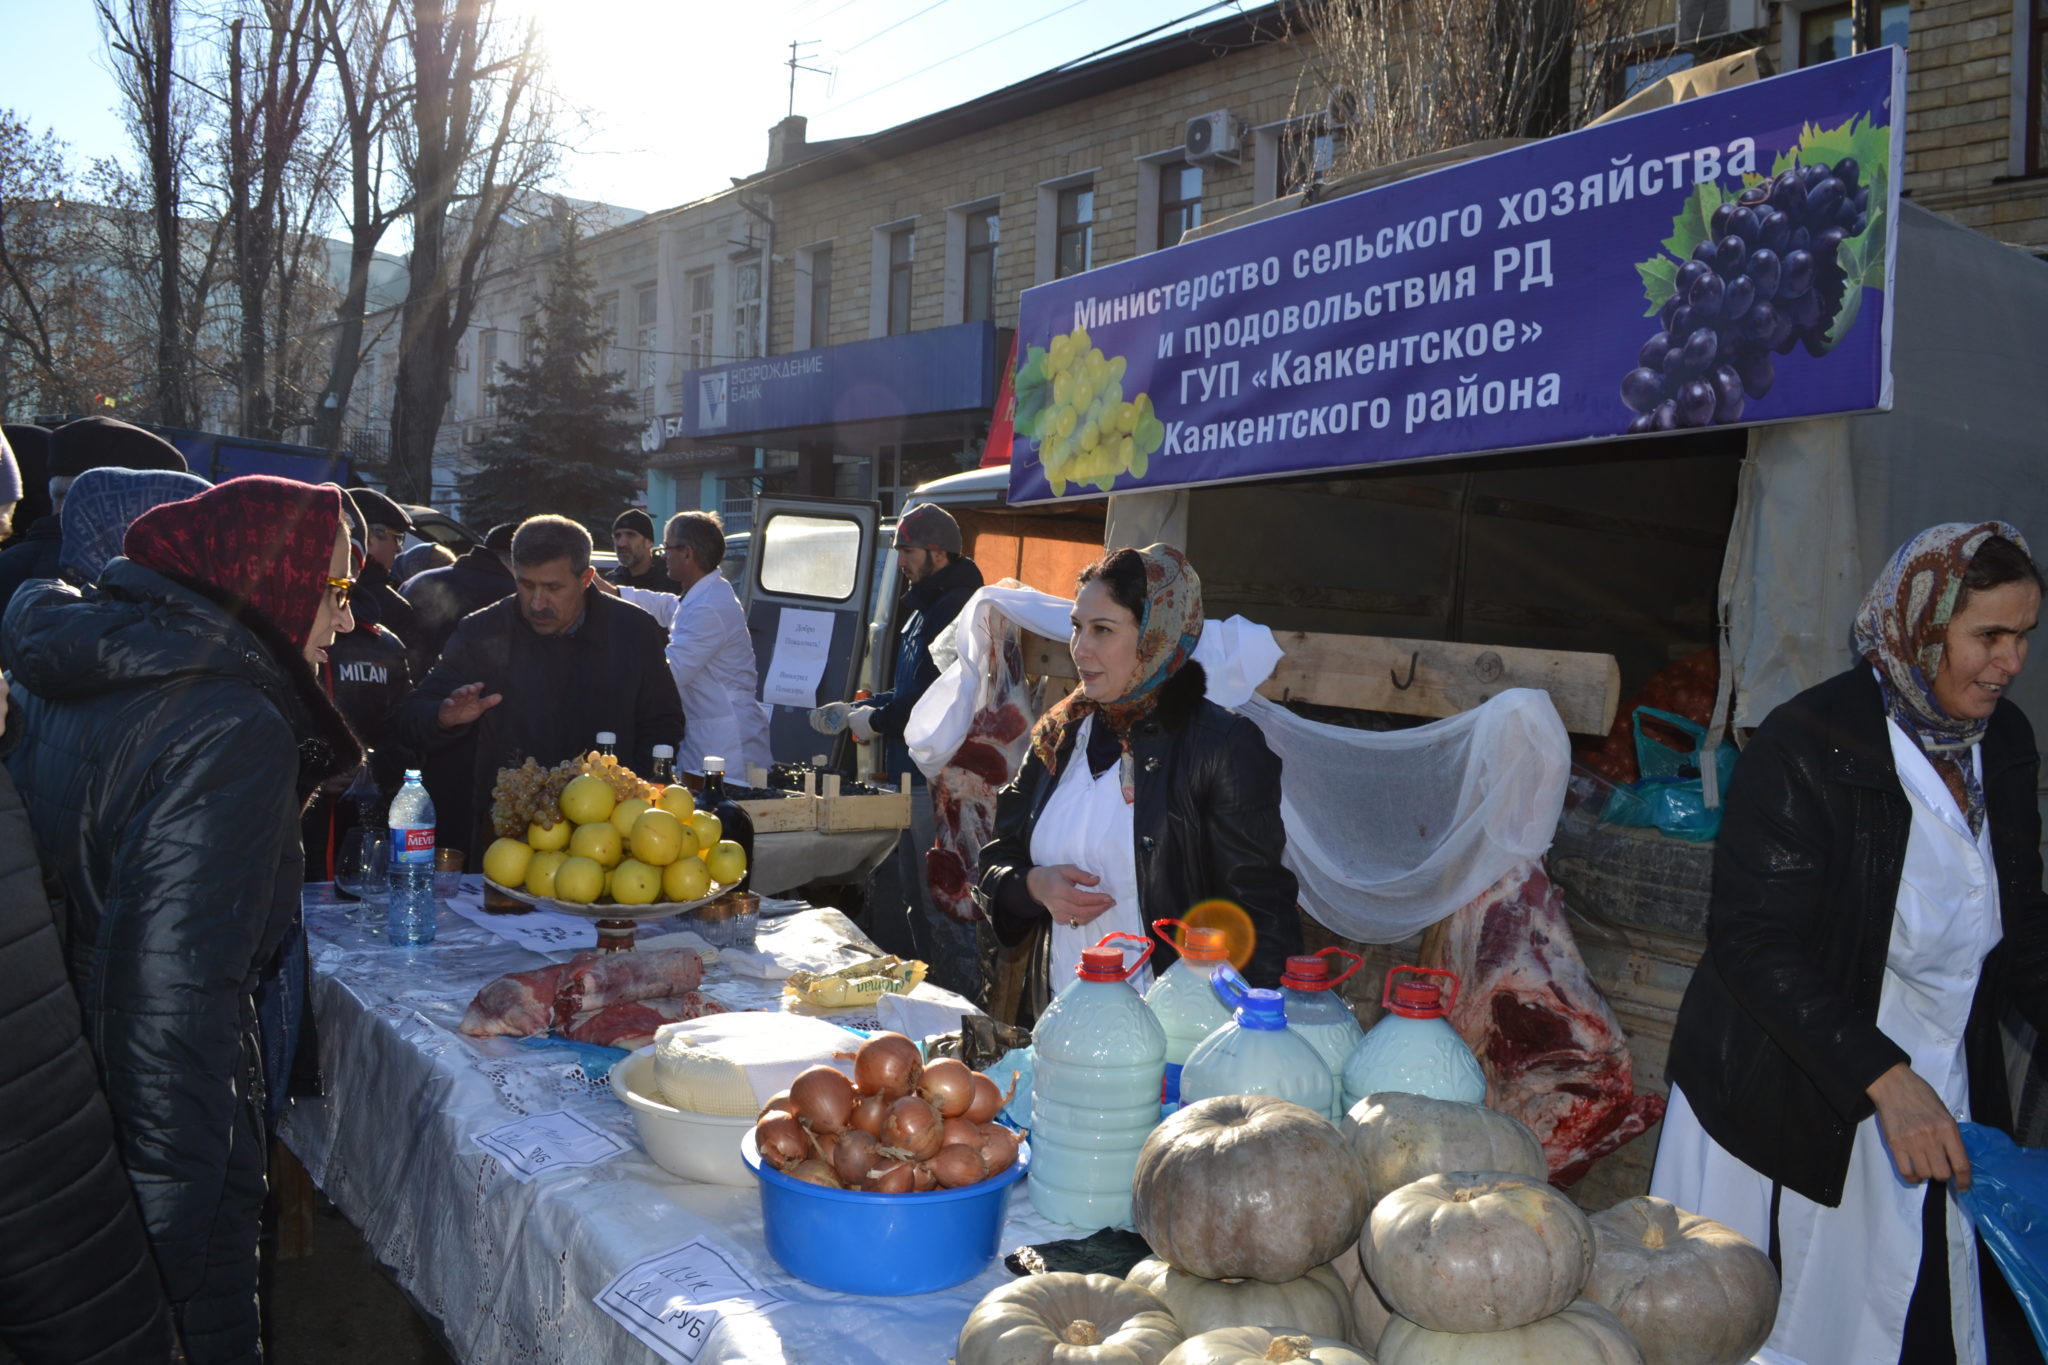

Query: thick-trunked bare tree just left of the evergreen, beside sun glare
[389,0,557,501]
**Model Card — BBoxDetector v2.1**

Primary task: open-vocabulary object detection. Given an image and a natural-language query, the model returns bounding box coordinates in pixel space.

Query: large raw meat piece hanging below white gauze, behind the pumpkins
[1442,862,1665,1185]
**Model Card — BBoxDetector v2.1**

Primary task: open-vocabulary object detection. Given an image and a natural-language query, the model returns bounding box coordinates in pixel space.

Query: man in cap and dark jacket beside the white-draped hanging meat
[811,503,983,1001]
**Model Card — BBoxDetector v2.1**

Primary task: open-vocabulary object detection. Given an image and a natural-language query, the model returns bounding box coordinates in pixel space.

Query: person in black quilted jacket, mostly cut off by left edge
[0,677,170,1365]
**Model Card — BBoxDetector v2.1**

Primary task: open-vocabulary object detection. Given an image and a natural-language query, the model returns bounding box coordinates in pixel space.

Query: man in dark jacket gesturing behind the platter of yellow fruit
[397,516,682,864]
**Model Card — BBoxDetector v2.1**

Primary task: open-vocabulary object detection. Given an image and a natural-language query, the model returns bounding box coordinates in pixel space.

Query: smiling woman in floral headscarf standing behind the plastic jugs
[975,544,1300,1017]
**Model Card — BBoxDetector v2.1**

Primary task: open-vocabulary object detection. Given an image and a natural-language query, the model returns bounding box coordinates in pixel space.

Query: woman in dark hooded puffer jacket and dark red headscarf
[4,477,360,1365]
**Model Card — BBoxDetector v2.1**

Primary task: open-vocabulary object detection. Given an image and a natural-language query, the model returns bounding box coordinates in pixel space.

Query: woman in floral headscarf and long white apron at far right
[1651,522,2048,1365]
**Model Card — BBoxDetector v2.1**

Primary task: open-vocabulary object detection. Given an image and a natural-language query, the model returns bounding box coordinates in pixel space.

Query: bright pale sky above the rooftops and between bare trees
[0,0,1257,222]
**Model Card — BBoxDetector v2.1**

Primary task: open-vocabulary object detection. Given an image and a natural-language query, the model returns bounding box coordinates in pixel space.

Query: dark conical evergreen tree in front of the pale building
[463,215,641,544]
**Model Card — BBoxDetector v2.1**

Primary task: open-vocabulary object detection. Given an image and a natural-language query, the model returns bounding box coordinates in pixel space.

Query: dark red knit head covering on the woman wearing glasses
[125,475,342,649]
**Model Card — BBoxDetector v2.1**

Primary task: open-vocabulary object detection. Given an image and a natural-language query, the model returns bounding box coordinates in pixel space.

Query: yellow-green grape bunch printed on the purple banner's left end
[1016,327,1165,497]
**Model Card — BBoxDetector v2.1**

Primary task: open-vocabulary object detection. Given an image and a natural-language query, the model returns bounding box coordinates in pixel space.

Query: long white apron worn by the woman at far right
[1651,722,2003,1365]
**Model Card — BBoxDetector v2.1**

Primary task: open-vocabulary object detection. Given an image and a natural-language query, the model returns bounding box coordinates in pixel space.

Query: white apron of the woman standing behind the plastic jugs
[1030,714,1151,995]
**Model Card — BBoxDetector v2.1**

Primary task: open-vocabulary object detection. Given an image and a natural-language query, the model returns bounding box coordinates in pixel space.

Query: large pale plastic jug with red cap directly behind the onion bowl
[1030,933,1165,1232]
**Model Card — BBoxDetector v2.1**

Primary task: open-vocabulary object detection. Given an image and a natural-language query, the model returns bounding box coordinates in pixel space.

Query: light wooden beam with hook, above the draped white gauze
[1024,630,1622,735]
